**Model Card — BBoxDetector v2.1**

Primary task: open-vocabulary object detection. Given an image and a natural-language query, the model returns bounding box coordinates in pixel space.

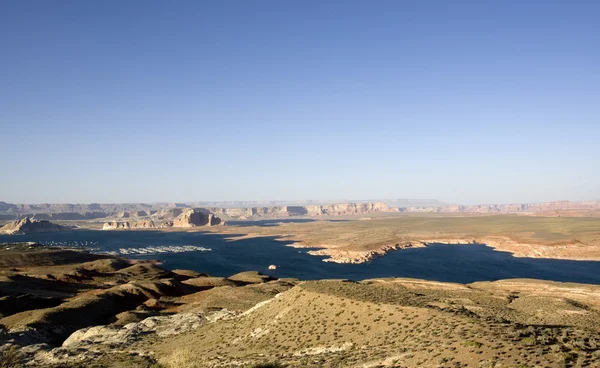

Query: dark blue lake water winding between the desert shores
[0,230,600,284]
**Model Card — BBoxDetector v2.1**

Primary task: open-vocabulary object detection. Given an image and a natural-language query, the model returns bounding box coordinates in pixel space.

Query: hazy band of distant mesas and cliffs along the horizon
[0,199,600,221]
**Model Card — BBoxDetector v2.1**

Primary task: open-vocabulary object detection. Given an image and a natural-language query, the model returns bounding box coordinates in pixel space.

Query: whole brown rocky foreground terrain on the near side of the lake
[0,246,600,368]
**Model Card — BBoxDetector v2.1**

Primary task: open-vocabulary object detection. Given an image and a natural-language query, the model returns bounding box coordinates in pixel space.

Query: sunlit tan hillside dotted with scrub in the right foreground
[153,280,600,368]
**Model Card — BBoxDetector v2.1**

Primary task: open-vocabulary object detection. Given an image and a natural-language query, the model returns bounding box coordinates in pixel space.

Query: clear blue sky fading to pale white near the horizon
[0,0,600,203]
